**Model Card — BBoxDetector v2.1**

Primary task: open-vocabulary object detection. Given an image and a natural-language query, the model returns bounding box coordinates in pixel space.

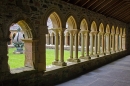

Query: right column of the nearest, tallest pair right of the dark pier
[58,30,66,66]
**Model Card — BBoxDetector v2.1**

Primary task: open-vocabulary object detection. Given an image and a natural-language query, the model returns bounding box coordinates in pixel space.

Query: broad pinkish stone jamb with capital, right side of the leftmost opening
[22,39,38,68]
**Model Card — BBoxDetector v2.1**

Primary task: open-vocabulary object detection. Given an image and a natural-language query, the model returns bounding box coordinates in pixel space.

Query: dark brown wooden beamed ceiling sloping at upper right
[62,0,130,23]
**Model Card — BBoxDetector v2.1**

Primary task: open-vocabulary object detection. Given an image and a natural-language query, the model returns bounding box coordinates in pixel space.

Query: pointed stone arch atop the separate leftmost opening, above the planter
[7,14,37,39]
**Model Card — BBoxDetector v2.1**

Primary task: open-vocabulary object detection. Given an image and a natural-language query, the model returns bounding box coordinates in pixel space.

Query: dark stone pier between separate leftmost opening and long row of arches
[35,25,48,71]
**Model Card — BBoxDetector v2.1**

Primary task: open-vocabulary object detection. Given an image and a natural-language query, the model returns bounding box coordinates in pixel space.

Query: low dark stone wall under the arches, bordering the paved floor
[0,51,127,86]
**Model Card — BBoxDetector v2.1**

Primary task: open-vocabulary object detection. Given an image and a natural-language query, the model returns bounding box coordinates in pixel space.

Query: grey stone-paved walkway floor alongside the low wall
[55,55,130,86]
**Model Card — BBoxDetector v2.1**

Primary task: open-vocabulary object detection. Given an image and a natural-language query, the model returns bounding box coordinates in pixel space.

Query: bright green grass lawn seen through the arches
[8,48,81,69]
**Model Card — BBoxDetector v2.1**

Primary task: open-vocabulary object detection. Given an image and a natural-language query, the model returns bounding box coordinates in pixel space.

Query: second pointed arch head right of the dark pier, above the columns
[66,16,77,29]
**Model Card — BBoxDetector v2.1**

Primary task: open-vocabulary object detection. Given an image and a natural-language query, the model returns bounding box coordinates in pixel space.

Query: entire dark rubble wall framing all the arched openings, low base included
[0,0,130,86]
